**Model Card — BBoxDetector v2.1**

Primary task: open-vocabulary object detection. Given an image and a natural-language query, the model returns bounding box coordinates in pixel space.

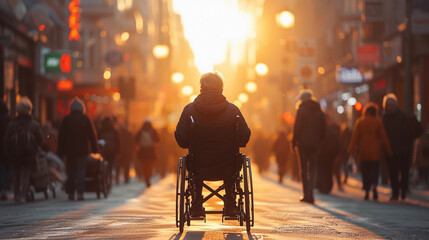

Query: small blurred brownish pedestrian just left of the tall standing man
[272,131,290,183]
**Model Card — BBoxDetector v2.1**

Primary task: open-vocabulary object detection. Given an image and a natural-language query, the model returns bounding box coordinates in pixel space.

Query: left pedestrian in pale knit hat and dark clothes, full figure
[58,97,98,200]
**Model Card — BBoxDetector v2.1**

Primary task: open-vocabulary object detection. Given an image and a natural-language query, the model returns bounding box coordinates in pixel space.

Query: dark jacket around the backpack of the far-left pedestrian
[4,114,43,168]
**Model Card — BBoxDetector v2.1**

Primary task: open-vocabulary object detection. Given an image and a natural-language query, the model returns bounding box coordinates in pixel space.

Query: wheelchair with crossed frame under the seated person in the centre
[176,117,254,233]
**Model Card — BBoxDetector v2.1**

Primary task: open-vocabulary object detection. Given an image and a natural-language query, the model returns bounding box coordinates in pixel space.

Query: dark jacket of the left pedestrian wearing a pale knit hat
[58,111,98,157]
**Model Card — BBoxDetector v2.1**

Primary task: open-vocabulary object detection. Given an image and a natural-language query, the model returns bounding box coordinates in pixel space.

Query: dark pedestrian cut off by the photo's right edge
[413,125,429,187]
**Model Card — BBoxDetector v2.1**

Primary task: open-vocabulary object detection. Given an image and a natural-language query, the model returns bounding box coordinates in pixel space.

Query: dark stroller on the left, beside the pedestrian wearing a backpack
[27,151,56,201]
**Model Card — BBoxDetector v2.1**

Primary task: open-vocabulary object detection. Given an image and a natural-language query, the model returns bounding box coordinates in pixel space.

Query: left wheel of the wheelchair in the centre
[176,157,186,232]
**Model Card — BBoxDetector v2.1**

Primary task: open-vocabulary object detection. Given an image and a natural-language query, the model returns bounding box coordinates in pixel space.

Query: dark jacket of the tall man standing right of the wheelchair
[293,100,326,152]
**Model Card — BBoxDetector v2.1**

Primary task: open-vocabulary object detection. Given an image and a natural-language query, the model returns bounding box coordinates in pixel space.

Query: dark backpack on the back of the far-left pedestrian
[9,124,37,158]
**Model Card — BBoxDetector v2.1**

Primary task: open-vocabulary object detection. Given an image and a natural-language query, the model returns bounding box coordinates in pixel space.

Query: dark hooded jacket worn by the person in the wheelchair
[174,91,250,180]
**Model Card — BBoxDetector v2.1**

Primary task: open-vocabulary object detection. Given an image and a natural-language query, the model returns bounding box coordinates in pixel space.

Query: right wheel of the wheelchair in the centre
[243,157,254,233]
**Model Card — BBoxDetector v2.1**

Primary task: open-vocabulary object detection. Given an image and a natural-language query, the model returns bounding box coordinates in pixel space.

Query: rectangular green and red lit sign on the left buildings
[45,52,72,73]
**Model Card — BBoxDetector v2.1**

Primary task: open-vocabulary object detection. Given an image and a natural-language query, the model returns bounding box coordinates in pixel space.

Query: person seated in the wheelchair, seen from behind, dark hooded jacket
[174,72,250,217]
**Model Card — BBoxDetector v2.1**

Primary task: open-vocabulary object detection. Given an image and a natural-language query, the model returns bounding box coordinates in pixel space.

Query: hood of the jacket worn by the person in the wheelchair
[194,91,229,116]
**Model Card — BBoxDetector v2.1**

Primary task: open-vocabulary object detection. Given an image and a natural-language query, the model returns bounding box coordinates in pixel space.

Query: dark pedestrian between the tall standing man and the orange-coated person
[315,116,341,194]
